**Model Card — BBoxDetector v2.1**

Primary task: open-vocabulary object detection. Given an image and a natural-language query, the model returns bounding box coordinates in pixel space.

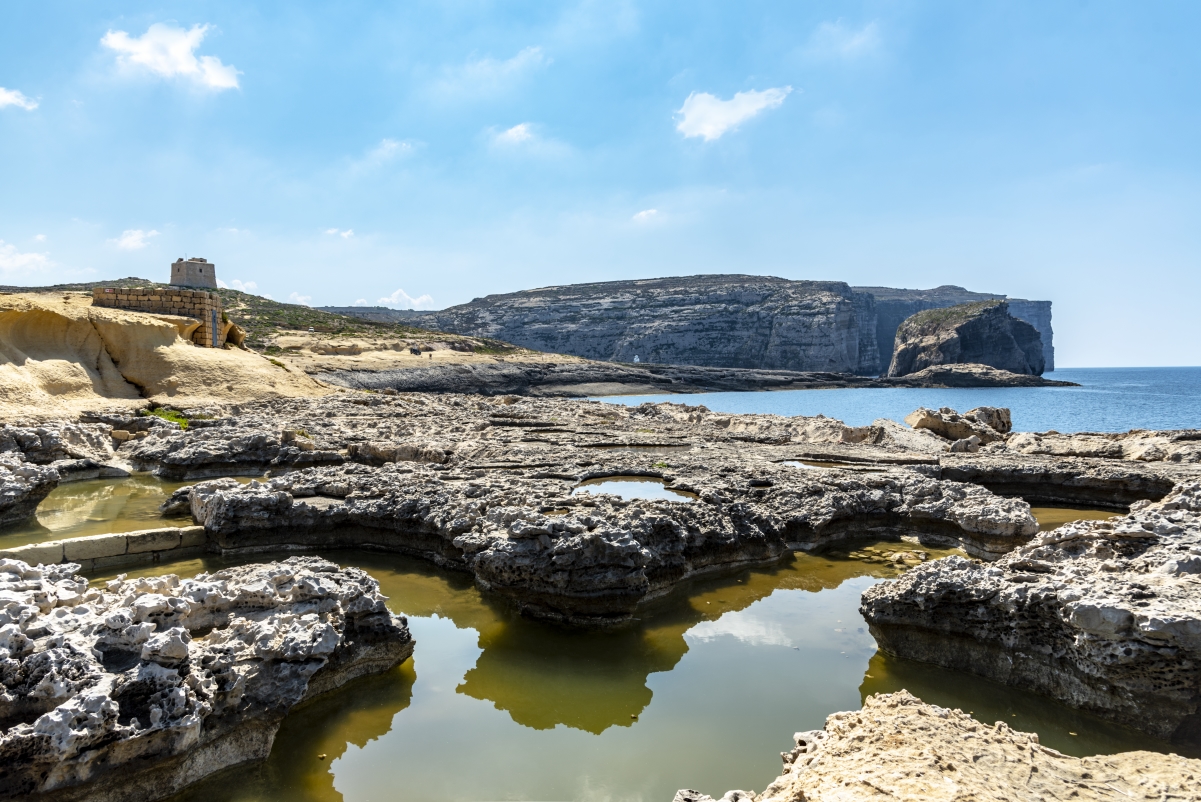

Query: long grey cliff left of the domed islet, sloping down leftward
[410,275,880,373]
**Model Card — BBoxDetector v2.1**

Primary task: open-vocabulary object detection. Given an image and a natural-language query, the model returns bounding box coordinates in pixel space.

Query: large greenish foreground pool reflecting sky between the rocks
[97,541,1169,802]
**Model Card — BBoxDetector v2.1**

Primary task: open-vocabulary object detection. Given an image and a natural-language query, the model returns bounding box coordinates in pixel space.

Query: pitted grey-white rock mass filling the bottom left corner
[0,557,413,802]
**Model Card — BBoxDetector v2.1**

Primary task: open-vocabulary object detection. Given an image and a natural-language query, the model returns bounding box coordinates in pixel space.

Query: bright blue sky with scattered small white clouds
[0,0,1201,366]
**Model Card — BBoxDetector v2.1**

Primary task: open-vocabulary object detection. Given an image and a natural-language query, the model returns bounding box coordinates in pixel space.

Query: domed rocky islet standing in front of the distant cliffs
[888,301,1045,376]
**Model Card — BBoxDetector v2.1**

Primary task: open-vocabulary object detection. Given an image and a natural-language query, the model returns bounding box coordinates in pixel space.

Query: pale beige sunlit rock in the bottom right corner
[675,690,1201,802]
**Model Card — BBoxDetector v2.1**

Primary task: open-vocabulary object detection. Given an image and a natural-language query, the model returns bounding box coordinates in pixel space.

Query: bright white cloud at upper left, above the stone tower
[100,23,241,90]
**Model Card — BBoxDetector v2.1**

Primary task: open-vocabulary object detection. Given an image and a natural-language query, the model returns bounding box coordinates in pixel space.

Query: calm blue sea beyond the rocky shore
[598,367,1201,432]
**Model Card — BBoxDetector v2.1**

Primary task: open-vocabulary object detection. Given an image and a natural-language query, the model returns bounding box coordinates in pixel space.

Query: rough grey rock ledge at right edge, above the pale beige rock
[861,483,1201,744]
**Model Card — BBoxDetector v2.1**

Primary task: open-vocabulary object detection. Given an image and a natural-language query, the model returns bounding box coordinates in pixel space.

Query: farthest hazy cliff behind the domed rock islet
[852,285,1054,371]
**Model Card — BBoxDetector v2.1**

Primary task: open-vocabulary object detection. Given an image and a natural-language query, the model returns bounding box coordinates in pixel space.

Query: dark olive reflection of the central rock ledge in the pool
[355,543,945,734]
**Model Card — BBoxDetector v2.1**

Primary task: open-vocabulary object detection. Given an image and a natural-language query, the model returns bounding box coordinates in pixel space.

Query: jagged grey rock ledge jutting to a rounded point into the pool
[168,448,1038,626]
